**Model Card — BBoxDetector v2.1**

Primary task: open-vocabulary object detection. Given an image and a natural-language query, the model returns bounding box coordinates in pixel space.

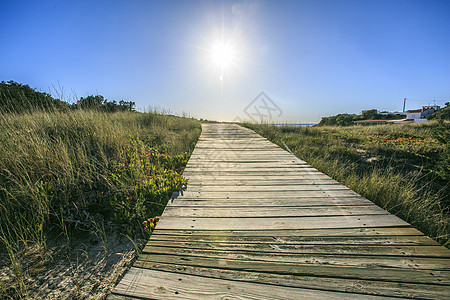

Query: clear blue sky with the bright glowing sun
[0,0,450,122]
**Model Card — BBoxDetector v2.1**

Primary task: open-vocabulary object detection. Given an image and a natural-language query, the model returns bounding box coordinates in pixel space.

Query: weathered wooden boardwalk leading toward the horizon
[110,124,450,299]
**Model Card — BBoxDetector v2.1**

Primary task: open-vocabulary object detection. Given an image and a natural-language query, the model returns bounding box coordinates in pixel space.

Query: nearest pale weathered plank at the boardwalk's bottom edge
[111,268,384,300]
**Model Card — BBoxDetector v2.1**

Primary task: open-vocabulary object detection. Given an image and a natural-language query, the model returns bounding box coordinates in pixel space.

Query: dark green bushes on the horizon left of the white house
[317,109,405,126]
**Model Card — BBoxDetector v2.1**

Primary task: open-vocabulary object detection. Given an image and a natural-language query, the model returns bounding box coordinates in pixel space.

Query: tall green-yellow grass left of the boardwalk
[0,110,201,297]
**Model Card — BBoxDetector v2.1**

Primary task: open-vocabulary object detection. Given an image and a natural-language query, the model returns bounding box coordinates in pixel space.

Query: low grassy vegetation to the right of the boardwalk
[246,122,450,247]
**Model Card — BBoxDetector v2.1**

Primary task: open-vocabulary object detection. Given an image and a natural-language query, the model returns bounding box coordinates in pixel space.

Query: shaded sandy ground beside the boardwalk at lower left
[0,234,144,299]
